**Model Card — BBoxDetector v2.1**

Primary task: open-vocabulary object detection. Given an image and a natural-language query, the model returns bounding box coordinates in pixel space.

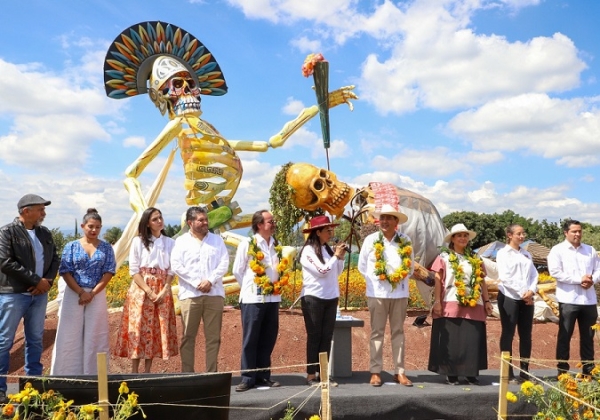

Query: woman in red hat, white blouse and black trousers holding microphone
[300,215,346,385]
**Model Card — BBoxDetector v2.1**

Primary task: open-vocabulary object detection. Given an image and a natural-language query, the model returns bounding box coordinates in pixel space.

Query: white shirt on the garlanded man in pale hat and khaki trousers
[358,231,414,299]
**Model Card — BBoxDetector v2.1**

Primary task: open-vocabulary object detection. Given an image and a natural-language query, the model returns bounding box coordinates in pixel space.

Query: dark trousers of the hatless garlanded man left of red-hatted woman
[239,302,279,386]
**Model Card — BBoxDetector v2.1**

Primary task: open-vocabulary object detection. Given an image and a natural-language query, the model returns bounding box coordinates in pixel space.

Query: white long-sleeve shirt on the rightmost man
[548,240,600,305]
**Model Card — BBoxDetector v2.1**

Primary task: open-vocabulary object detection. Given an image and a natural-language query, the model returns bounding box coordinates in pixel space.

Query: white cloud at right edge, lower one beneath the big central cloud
[448,93,600,167]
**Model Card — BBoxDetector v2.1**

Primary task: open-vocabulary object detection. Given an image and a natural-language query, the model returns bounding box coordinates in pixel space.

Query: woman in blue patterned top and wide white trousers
[50,209,116,376]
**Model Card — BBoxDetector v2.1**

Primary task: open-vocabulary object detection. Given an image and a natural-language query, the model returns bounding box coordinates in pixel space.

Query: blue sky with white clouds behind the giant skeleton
[0,0,600,230]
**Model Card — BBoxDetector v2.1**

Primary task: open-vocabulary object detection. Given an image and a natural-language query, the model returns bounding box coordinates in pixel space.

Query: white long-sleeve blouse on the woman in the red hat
[300,245,344,299]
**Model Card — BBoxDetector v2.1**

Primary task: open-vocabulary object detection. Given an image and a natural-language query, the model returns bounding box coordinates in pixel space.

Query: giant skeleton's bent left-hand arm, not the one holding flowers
[124,117,182,214]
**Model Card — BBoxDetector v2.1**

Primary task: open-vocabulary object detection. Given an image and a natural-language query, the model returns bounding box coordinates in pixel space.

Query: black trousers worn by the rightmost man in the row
[556,303,598,375]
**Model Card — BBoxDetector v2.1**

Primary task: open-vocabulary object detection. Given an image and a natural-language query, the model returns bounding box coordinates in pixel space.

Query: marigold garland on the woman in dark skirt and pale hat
[441,244,485,308]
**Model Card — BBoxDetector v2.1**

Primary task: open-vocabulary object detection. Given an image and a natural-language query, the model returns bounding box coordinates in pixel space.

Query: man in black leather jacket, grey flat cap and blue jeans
[0,194,59,404]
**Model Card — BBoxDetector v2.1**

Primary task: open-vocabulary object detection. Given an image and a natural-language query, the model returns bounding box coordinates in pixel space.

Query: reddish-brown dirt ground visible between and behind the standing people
[4,308,579,383]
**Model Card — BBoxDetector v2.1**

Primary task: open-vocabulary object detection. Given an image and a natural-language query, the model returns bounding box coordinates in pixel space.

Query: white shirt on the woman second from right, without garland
[496,245,538,300]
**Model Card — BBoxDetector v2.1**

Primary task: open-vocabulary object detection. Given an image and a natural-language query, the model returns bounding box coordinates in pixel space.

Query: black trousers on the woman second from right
[498,292,534,377]
